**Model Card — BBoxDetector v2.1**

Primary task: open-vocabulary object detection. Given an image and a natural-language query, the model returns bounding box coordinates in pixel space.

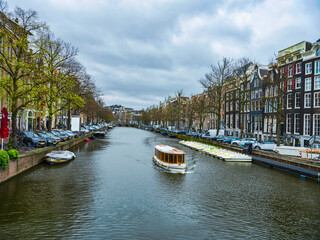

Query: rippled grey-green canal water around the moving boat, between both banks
[0,127,320,239]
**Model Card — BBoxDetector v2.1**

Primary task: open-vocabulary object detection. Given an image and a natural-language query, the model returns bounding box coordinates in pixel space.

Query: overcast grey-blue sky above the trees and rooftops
[7,0,320,109]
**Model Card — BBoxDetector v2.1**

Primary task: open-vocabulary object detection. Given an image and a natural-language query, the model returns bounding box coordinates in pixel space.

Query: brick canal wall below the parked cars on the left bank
[0,134,91,184]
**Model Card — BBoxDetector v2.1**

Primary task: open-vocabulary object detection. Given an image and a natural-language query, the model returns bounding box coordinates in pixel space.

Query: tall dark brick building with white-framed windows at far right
[278,40,320,146]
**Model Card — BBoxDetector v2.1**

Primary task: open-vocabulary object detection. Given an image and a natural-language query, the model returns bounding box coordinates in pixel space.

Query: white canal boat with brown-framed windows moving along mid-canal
[153,145,188,173]
